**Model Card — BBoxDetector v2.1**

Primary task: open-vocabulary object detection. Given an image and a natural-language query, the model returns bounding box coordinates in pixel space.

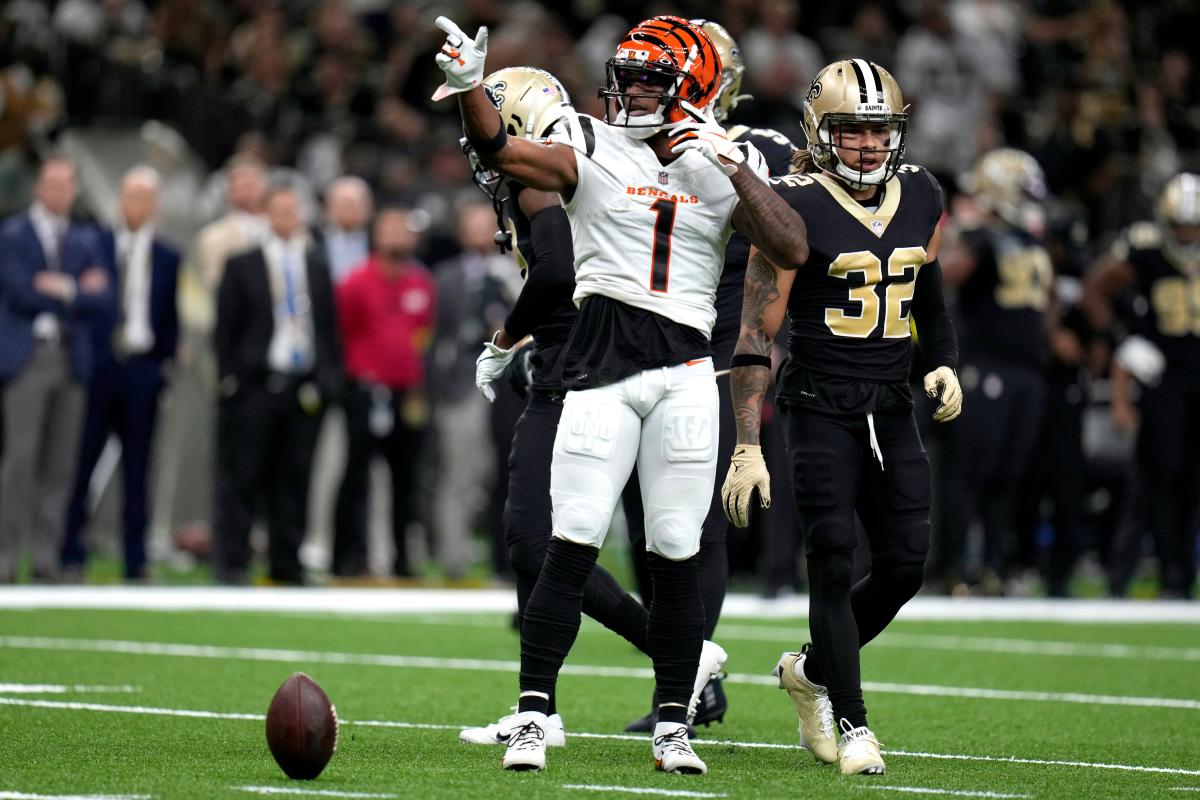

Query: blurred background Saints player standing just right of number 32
[931,148,1060,595]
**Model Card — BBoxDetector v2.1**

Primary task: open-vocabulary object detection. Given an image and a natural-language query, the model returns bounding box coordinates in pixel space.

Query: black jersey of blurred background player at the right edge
[1112,222,1200,381]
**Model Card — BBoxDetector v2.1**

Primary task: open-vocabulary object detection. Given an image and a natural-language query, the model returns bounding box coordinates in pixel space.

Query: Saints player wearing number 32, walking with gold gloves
[722,59,962,775]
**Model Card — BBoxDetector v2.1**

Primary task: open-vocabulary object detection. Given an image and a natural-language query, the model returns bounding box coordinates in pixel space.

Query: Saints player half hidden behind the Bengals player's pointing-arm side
[458,67,720,746]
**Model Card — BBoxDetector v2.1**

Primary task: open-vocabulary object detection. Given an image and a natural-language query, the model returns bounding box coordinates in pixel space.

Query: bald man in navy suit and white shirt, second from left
[62,167,179,581]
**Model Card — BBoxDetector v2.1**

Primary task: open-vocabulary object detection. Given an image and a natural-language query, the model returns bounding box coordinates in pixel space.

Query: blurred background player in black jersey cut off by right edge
[1084,173,1200,597]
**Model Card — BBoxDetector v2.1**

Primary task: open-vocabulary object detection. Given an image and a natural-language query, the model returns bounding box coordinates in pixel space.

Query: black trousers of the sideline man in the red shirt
[332,381,425,576]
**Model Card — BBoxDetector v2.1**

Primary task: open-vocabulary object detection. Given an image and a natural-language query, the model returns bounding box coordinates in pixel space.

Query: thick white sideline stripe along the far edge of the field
[0,587,1200,625]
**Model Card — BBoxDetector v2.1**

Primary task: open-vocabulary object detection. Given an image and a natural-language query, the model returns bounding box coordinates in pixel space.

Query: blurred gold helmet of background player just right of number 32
[961,148,1046,234]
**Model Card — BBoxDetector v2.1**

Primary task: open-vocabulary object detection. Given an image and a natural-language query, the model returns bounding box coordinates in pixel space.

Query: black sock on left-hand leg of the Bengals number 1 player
[521,539,600,706]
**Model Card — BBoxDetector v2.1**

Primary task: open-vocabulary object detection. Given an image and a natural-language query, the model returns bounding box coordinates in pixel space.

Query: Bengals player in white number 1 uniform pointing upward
[433,17,808,774]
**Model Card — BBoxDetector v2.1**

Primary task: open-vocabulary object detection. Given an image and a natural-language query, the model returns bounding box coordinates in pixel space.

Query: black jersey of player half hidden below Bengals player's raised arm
[504,182,580,391]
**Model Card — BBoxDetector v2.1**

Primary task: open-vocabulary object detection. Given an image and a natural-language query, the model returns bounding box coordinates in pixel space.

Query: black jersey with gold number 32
[772,164,942,413]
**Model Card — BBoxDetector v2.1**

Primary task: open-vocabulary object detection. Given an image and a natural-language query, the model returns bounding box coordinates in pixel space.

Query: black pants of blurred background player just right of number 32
[935,356,1046,585]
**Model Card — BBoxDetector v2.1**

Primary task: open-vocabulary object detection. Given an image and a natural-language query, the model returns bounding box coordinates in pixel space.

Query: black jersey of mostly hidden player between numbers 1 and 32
[710,125,796,359]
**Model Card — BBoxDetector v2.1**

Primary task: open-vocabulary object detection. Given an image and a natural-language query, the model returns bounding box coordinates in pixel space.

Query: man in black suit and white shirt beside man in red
[212,186,342,584]
